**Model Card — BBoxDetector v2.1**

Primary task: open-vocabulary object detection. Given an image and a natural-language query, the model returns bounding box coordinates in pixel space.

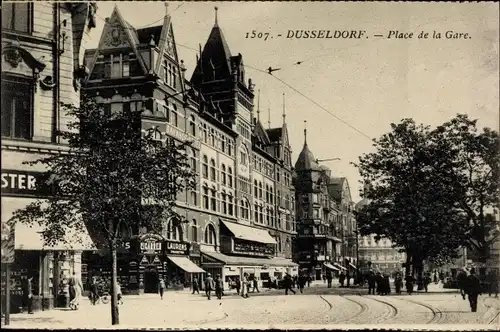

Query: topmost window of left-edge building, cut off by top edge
[2,2,33,33]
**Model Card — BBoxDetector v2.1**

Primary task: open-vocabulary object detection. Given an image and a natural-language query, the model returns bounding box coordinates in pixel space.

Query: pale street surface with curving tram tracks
[4,287,500,329]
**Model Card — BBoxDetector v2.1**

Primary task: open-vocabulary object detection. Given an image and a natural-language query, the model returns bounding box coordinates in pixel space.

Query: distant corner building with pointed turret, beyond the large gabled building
[294,130,356,280]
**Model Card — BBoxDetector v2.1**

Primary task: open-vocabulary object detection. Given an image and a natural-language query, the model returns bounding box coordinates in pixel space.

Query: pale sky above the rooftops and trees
[87,1,500,201]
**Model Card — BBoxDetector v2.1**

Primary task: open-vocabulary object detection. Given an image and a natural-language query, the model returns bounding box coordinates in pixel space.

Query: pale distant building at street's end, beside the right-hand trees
[355,187,406,273]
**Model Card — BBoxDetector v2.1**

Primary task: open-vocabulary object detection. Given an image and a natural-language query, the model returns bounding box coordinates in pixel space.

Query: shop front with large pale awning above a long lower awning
[201,220,298,289]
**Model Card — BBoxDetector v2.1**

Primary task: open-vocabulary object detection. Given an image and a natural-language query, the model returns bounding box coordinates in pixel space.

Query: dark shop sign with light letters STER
[2,169,53,197]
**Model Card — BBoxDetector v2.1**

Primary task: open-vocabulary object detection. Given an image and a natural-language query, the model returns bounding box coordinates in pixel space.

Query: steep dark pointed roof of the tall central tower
[191,23,234,85]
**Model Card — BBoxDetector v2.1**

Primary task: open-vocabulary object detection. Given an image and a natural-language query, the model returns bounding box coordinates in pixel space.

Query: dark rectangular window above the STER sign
[2,79,33,139]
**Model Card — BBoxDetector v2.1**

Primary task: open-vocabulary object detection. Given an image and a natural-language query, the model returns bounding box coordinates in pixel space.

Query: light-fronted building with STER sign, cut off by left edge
[1,1,97,311]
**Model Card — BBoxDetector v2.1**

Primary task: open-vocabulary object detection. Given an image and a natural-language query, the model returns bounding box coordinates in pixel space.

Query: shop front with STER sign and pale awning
[1,169,94,313]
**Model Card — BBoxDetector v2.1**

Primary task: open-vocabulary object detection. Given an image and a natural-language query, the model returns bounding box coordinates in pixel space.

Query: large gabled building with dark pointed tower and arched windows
[80,3,296,292]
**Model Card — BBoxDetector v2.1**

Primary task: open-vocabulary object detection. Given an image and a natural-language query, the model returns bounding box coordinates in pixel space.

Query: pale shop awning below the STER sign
[14,223,97,250]
